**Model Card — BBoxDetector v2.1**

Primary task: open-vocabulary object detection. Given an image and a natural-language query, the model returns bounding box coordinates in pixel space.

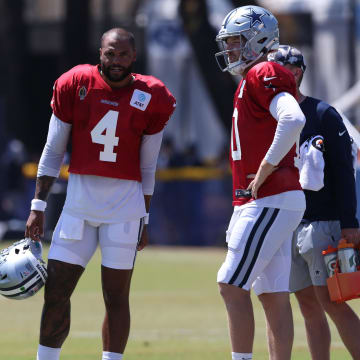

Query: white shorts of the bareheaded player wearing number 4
[48,213,143,270]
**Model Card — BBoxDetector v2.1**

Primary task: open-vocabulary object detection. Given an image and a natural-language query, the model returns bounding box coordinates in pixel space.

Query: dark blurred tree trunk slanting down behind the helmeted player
[179,0,257,130]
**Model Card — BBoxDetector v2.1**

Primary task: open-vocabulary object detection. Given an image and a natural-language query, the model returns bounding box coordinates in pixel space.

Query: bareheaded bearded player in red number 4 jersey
[25,28,176,360]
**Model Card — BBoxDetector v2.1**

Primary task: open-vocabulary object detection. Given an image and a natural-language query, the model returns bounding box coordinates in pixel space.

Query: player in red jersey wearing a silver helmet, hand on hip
[215,6,305,360]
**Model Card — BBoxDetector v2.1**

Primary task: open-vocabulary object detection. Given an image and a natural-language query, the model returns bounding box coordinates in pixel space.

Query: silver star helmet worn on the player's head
[215,5,279,75]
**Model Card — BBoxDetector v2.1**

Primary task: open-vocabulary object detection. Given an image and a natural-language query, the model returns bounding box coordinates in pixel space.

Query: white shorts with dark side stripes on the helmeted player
[217,206,303,295]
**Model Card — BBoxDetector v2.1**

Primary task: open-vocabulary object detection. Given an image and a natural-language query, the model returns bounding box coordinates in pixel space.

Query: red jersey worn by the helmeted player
[230,62,301,205]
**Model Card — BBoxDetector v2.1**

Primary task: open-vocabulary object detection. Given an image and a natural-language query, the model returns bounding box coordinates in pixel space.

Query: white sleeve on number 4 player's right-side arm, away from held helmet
[140,130,164,195]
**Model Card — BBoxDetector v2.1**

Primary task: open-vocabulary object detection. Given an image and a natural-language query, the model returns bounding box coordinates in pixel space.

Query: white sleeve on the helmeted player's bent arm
[265,92,305,165]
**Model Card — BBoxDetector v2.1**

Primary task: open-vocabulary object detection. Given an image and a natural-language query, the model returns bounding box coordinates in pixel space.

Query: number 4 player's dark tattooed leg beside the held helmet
[40,260,84,348]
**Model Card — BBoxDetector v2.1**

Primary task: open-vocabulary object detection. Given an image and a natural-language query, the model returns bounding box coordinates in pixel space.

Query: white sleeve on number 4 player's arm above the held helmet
[37,114,71,177]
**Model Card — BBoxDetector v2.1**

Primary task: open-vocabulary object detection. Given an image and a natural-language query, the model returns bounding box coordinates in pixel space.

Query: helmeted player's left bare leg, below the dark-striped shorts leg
[219,283,255,353]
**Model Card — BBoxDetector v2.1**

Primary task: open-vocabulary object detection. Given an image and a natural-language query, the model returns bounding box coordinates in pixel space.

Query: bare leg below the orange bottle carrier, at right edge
[314,286,360,360]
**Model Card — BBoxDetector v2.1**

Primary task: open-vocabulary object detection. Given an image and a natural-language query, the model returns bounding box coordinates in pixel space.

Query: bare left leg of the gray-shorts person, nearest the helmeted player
[295,286,331,360]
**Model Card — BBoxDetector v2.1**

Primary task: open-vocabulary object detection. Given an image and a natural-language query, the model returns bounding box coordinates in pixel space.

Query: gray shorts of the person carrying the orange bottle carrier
[289,221,341,292]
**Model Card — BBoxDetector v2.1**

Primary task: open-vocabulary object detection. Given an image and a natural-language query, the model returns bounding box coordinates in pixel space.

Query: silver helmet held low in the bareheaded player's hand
[0,239,47,300]
